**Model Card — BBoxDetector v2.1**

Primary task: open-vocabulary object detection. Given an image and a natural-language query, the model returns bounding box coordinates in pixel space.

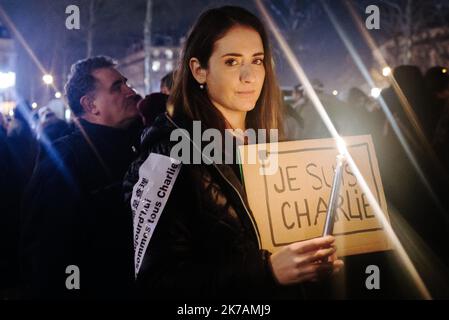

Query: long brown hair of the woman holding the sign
[168,6,282,135]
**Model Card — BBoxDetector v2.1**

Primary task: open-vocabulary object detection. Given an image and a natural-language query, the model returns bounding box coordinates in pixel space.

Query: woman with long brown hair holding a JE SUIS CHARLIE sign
[125,6,342,298]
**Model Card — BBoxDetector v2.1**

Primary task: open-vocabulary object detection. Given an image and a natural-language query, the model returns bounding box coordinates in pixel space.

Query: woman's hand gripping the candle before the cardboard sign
[270,236,343,285]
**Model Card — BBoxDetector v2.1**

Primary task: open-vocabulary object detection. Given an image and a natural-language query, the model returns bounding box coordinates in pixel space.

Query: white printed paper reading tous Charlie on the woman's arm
[131,153,181,277]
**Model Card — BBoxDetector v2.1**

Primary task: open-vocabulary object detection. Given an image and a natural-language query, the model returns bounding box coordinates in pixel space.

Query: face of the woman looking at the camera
[206,26,265,119]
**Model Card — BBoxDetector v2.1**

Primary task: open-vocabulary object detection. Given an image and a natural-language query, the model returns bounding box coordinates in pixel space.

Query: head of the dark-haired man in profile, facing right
[65,56,141,128]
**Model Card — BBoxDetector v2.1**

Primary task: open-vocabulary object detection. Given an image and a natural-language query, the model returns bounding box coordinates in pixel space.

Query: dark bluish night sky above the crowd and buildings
[0,0,412,102]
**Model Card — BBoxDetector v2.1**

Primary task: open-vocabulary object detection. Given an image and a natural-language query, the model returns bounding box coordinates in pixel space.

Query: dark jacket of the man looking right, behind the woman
[20,120,142,299]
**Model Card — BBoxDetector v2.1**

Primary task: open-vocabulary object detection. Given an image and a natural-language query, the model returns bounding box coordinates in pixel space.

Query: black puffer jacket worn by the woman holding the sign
[124,115,284,299]
